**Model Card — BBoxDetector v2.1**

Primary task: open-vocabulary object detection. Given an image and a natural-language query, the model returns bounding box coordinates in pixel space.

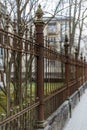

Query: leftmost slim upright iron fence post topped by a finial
[4,15,11,116]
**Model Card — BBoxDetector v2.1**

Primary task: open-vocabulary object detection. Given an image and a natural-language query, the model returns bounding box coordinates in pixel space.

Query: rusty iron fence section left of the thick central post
[0,29,39,130]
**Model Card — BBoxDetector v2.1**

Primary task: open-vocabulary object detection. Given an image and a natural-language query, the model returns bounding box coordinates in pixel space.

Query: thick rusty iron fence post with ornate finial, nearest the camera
[35,5,45,128]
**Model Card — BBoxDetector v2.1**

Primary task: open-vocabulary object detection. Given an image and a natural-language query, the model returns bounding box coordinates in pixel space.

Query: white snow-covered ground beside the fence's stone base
[63,90,87,130]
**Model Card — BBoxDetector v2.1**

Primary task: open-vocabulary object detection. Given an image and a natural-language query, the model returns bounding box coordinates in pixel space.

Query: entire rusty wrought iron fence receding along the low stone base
[0,6,87,130]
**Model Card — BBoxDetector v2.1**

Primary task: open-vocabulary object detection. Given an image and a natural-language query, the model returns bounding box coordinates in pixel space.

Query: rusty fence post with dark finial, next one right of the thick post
[64,35,70,97]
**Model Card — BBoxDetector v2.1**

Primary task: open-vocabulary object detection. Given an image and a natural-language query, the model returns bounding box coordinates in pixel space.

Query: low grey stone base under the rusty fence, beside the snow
[38,82,87,130]
